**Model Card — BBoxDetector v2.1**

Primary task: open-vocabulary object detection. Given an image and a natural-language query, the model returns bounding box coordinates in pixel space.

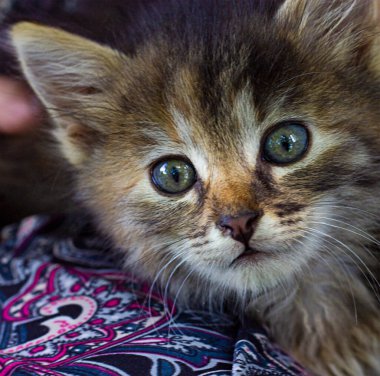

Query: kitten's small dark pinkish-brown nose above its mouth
[217,211,260,246]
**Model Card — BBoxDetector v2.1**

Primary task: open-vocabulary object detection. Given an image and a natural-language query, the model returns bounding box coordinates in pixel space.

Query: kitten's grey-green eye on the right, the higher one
[263,122,309,164]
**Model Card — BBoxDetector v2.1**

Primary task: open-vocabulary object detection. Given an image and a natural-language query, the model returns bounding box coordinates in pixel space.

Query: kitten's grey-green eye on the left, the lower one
[152,159,197,194]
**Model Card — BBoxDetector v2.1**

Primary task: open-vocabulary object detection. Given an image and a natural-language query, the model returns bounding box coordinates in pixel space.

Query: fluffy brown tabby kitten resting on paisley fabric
[5,0,380,376]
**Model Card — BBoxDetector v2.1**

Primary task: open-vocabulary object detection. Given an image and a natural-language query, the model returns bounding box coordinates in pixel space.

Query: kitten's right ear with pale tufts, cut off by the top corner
[276,0,380,70]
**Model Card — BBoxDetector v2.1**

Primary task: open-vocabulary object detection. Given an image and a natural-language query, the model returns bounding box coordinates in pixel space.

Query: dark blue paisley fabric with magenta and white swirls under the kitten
[0,216,306,376]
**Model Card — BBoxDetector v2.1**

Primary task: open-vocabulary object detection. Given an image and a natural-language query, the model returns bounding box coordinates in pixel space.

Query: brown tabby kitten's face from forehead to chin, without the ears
[11,2,380,300]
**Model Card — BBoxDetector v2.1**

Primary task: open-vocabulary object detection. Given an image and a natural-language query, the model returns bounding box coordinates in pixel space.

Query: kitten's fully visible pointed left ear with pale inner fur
[11,22,125,165]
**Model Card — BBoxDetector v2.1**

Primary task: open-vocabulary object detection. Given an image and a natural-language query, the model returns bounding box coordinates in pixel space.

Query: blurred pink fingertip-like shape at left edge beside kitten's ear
[0,76,41,134]
